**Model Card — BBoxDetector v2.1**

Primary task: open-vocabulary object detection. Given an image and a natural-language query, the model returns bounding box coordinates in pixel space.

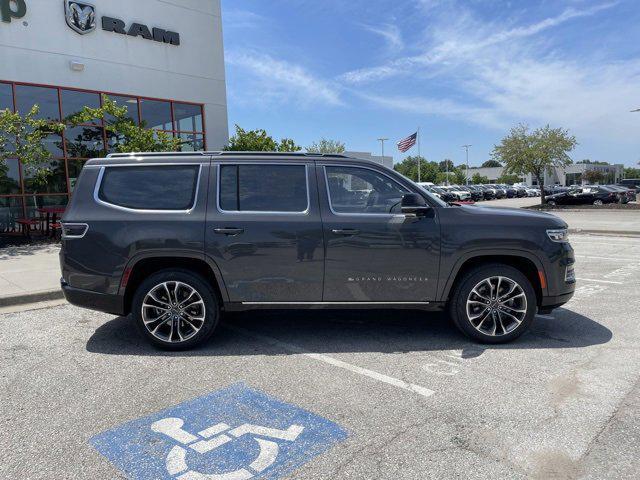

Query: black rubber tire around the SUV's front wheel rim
[449,263,538,344]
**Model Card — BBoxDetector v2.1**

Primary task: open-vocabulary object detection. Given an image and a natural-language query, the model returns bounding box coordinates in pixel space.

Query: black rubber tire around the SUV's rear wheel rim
[132,269,220,351]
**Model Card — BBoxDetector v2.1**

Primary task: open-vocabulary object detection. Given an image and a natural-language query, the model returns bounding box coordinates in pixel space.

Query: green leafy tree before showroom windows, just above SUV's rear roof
[68,95,182,155]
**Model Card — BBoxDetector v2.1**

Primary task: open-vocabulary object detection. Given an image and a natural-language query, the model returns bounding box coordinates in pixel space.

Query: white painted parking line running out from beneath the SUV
[224,325,435,397]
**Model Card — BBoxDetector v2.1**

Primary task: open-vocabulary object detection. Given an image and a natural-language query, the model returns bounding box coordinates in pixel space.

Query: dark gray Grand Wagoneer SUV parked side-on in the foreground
[60,152,575,350]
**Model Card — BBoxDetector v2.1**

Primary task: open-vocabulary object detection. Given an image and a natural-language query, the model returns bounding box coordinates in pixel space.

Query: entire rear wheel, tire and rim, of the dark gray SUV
[133,270,220,350]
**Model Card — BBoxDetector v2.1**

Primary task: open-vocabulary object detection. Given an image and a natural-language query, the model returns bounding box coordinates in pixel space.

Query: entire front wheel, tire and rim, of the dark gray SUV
[449,264,537,343]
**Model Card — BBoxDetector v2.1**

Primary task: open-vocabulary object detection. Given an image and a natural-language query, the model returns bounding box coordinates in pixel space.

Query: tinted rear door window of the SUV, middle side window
[218,164,309,213]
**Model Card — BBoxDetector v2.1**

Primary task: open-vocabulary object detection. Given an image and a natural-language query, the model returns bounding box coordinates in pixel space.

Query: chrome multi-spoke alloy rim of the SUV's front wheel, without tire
[467,277,527,337]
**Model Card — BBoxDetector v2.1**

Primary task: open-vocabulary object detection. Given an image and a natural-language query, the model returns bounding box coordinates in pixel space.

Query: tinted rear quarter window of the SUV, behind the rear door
[98,165,200,210]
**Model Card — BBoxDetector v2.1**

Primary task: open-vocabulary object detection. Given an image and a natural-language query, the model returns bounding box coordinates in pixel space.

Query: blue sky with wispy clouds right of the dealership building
[222,0,640,166]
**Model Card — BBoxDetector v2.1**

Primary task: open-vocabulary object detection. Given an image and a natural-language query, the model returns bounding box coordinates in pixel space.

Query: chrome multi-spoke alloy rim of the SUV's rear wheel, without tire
[142,282,206,343]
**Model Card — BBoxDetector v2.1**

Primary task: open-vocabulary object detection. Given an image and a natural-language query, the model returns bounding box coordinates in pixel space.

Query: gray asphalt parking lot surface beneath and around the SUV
[0,235,640,479]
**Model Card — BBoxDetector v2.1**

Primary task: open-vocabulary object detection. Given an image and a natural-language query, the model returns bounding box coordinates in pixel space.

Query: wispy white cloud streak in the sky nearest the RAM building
[226,51,342,106]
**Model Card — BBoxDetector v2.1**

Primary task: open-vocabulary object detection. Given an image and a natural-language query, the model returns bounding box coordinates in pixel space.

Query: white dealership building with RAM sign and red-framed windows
[0,0,229,226]
